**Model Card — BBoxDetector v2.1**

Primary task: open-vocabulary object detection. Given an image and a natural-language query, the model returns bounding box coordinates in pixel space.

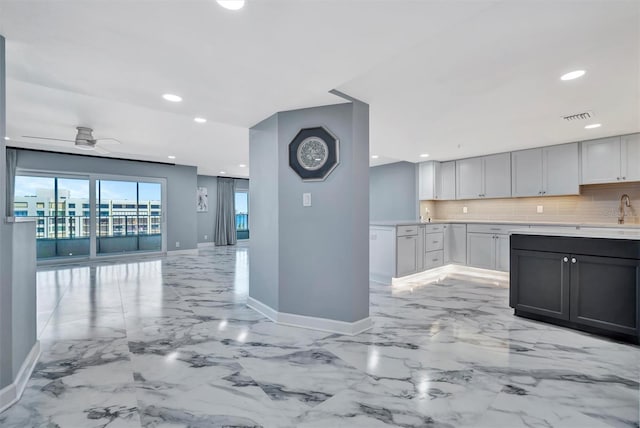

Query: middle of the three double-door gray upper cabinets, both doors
[511,143,580,197]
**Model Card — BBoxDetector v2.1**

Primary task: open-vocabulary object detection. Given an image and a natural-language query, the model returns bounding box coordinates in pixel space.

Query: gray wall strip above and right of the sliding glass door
[18,150,198,251]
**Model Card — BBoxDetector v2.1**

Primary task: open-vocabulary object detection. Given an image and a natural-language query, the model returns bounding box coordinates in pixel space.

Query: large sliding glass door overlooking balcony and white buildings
[14,172,166,260]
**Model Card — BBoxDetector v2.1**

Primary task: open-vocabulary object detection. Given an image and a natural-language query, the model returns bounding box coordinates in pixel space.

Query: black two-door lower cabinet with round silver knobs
[509,235,640,343]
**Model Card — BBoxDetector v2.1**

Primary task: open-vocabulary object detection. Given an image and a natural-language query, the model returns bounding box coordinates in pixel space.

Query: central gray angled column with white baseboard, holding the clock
[249,98,371,334]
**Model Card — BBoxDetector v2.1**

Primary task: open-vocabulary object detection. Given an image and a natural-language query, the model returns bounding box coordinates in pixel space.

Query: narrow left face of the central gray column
[249,114,280,310]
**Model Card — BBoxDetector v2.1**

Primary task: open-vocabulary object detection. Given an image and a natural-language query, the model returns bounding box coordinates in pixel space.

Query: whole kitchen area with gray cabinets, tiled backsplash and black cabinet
[370,134,640,344]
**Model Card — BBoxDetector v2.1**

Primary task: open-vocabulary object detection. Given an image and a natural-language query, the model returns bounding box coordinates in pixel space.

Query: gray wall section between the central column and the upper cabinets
[369,162,419,220]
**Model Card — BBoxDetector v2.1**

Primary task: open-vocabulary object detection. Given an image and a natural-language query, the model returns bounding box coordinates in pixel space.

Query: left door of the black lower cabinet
[510,250,571,320]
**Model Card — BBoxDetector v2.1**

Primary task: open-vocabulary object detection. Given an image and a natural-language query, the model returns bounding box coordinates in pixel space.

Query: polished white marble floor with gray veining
[0,245,640,428]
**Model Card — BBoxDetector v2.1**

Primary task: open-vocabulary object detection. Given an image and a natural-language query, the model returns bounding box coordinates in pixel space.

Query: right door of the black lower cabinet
[571,255,640,336]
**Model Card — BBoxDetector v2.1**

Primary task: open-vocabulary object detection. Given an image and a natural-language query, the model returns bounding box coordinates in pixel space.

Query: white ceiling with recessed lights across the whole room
[0,0,640,176]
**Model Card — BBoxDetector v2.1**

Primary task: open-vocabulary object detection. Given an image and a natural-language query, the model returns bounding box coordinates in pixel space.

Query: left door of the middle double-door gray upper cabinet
[511,149,540,196]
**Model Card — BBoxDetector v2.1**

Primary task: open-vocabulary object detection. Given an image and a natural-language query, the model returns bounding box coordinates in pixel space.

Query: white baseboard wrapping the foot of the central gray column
[247,297,373,336]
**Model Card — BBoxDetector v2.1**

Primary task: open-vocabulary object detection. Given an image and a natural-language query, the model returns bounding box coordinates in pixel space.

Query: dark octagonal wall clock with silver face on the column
[289,126,340,181]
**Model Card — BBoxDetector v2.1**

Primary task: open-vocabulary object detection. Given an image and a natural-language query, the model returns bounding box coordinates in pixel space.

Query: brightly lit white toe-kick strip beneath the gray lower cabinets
[391,264,509,287]
